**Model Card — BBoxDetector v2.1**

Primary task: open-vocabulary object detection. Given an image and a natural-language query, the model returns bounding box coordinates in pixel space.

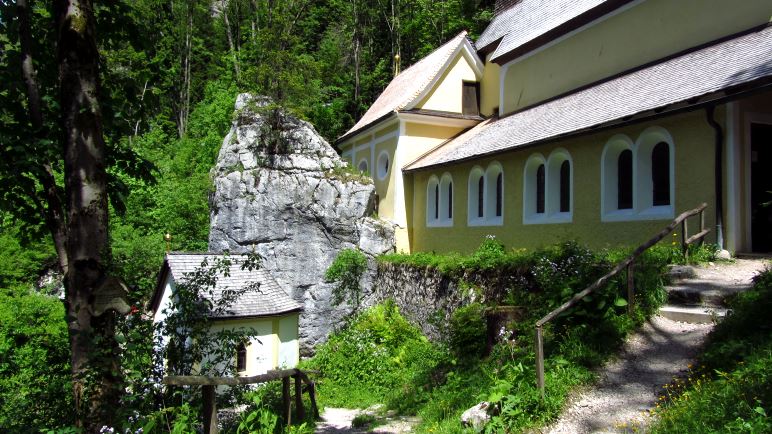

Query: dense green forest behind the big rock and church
[0,0,493,429]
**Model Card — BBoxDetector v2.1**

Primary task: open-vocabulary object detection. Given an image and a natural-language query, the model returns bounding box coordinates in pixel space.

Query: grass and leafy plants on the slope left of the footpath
[305,238,672,433]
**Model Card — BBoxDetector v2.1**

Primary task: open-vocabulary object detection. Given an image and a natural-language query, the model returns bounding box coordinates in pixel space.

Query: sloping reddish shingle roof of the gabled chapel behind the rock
[338,31,467,140]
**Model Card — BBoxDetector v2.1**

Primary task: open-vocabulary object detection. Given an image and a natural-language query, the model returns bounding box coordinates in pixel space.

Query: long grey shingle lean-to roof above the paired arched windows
[405,27,772,171]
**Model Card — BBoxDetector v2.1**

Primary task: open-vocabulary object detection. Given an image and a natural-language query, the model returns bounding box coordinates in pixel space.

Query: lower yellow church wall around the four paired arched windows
[411,111,721,253]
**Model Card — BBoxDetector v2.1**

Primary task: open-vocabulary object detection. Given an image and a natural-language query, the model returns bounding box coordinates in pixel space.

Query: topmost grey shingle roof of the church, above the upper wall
[475,0,605,60]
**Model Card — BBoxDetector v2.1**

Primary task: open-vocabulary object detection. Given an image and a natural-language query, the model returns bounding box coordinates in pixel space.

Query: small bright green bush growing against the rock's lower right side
[324,249,367,311]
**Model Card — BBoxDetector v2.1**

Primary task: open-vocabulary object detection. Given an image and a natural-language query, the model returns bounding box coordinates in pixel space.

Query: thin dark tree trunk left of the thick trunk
[16,0,67,273]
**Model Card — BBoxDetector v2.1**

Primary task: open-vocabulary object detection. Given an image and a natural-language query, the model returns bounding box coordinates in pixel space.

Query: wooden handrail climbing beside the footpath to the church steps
[535,203,710,398]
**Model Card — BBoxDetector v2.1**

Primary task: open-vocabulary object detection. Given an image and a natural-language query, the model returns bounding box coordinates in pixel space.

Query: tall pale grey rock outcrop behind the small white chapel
[209,94,395,354]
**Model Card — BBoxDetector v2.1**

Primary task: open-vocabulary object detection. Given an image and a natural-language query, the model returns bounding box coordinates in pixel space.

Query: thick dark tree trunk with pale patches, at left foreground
[54,0,121,432]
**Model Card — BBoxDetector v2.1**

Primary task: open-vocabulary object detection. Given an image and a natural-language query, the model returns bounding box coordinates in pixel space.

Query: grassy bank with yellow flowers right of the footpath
[652,269,772,433]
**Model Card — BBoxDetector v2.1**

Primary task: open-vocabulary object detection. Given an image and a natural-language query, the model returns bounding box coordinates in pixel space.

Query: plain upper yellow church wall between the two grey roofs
[498,0,772,114]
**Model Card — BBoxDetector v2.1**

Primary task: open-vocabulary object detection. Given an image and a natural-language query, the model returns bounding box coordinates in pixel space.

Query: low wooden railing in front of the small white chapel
[163,368,319,434]
